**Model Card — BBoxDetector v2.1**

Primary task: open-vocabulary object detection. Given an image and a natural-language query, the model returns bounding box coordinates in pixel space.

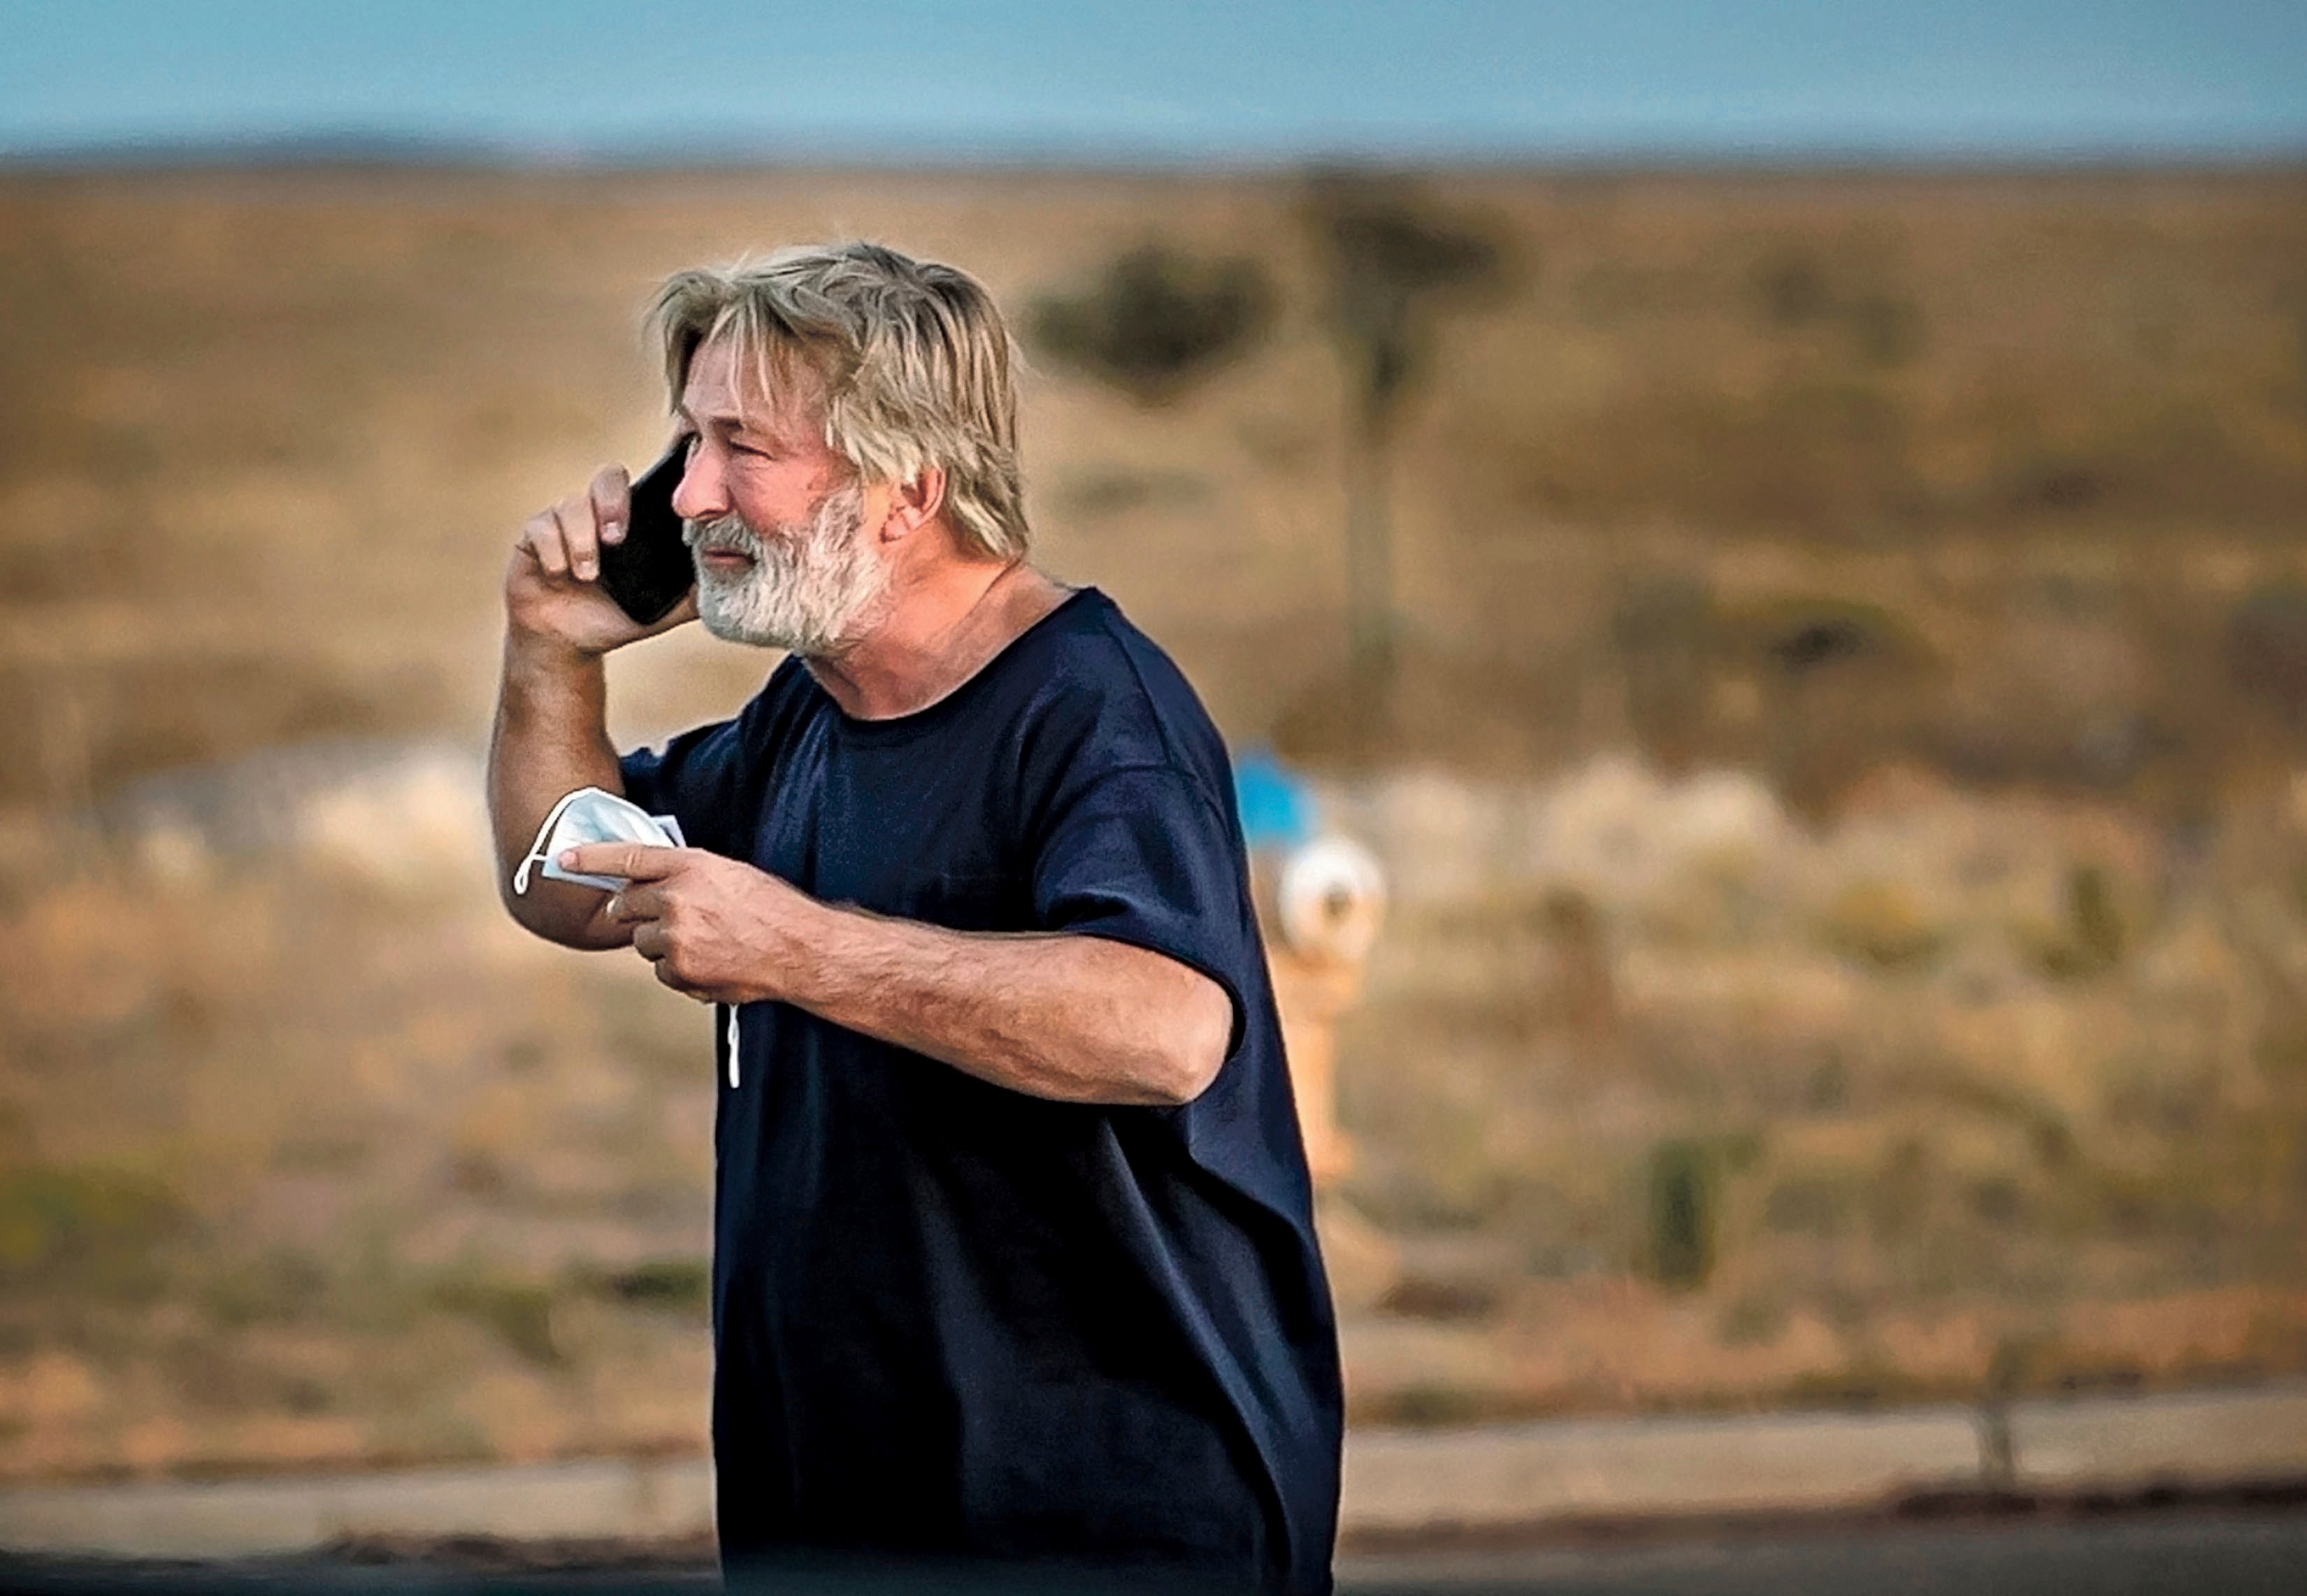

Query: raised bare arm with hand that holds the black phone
[489,466,697,948]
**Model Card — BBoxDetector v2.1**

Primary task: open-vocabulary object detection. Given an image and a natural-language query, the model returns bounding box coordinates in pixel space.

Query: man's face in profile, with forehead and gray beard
[674,339,889,655]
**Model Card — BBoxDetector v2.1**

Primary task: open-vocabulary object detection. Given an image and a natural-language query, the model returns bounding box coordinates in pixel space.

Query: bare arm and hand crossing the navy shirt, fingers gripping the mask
[568,844,1235,1105]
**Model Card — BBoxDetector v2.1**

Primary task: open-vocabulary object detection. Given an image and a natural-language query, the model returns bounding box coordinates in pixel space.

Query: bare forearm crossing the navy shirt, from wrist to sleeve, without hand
[779,904,1235,1105]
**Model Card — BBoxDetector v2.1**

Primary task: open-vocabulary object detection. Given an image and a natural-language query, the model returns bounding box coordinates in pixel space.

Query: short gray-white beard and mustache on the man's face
[683,482,889,655]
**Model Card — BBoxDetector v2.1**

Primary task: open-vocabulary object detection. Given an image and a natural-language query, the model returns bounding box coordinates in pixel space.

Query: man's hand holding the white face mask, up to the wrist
[561,842,819,1003]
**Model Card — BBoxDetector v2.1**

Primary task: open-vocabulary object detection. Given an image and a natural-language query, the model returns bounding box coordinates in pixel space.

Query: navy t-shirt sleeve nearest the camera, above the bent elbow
[1033,765,1260,1058]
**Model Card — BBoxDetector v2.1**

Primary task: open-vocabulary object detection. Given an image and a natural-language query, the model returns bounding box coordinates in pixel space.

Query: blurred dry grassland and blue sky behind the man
[0,0,2307,1483]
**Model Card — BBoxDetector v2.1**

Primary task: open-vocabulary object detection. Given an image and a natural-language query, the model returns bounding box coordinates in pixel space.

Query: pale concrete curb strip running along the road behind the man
[17,1381,2307,1559]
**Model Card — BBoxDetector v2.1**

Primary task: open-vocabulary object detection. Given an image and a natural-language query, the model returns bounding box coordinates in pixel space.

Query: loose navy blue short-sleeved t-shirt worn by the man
[623,588,1343,1591]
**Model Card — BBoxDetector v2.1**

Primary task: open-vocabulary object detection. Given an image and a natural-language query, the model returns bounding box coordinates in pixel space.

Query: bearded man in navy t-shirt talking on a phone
[489,245,1340,1591]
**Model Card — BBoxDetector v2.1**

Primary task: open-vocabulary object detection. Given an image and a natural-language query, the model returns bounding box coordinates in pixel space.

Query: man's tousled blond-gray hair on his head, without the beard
[648,242,1027,561]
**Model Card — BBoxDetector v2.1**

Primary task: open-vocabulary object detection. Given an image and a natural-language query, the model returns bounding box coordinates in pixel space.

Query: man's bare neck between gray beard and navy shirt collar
[803,561,1070,719]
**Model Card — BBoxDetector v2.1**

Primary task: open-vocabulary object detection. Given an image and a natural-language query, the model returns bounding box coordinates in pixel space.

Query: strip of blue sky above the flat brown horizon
[0,0,2307,161]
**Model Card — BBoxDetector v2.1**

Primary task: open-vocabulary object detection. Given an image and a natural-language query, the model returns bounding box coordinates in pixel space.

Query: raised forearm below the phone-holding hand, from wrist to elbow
[489,637,632,948]
